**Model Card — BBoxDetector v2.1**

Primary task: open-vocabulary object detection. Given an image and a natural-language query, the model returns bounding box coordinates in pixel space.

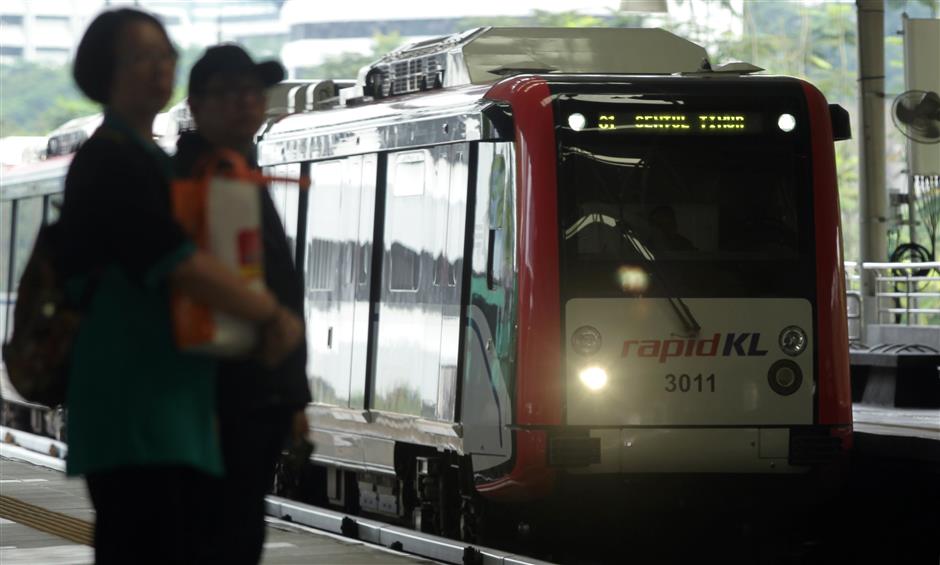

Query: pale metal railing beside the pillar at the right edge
[845,261,940,339]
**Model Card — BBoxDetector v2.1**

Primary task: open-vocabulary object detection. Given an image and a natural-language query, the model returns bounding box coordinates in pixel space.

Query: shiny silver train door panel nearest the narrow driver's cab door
[373,144,468,420]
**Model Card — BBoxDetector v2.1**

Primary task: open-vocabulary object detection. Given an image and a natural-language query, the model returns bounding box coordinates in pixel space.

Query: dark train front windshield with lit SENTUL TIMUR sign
[555,88,814,299]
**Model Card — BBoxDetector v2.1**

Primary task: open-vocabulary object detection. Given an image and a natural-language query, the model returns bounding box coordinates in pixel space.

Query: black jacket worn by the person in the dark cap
[174,132,311,413]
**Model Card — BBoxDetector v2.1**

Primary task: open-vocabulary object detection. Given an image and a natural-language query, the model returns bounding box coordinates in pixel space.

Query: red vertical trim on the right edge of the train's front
[801,81,852,430]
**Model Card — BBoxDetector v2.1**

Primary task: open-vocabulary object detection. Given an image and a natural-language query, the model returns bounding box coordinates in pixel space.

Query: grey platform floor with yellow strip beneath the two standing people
[0,454,435,565]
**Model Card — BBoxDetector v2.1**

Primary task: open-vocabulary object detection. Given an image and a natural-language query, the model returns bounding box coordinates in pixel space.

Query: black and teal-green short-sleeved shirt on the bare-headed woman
[62,116,222,475]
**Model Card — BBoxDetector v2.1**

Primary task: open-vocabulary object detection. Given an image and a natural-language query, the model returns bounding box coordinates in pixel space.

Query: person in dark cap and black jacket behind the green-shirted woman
[175,44,311,564]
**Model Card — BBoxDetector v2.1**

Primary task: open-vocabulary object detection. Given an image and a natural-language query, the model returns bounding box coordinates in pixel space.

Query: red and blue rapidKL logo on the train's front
[620,332,767,363]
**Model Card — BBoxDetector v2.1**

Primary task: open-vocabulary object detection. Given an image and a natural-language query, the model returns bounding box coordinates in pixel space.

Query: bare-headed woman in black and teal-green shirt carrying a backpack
[61,9,302,563]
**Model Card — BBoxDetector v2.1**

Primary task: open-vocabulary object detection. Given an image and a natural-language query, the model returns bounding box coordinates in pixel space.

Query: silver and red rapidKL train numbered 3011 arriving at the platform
[0,27,853,539]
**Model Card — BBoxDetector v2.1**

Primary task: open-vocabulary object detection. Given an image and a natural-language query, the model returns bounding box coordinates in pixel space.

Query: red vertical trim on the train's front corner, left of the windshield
[477,76,562,499]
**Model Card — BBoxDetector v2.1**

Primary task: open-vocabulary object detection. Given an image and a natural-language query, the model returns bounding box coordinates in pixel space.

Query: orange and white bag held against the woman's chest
[170,150,303,357]
